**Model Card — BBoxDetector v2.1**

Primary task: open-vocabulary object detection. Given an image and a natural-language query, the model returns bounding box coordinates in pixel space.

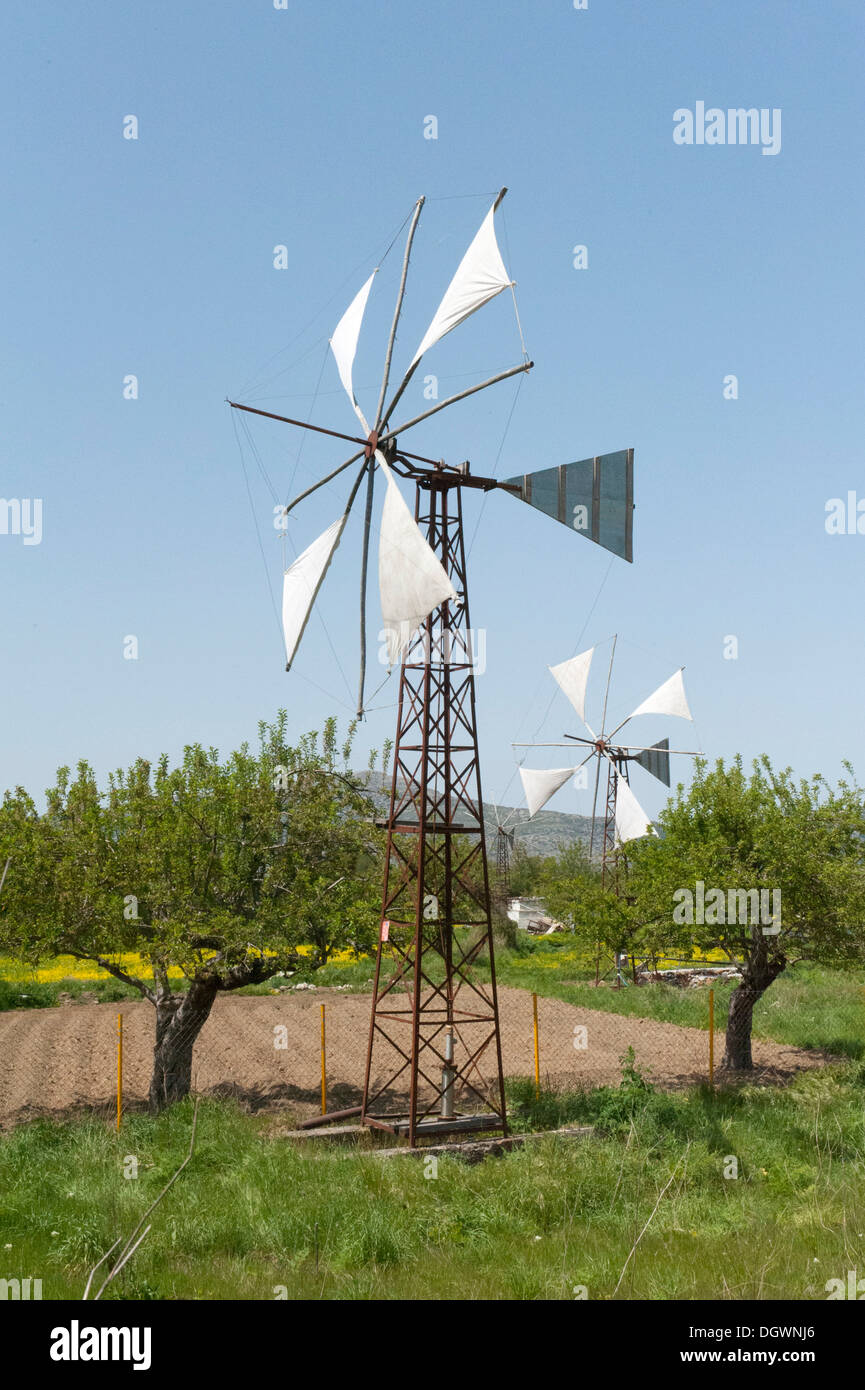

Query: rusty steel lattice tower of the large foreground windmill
[362,466,508,1145]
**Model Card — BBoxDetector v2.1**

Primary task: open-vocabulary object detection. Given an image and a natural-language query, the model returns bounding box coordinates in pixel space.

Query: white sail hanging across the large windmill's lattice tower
[375,450,458,666]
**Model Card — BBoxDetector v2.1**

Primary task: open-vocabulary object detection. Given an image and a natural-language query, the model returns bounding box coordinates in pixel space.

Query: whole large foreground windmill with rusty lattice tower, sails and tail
[229,189,633,1147]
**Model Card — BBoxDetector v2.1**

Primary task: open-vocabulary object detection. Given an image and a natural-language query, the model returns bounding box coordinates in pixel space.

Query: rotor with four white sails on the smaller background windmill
[515,637,700,887]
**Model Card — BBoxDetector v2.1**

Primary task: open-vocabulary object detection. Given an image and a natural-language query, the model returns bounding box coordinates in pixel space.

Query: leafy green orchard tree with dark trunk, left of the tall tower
[0,712,381,1111]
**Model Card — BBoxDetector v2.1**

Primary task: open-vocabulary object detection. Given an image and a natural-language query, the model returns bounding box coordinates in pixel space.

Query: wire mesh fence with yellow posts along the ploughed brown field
[0,963,865,1127]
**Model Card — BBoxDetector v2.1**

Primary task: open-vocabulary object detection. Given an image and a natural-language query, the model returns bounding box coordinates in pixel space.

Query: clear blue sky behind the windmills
[0,0,865,813]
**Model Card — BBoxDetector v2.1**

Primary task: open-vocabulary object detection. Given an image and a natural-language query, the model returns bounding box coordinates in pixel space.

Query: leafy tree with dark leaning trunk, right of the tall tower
[627,756,865,1070]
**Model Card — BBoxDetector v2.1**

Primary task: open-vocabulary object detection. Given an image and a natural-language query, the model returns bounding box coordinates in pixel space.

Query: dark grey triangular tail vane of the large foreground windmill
[499,449,634,562]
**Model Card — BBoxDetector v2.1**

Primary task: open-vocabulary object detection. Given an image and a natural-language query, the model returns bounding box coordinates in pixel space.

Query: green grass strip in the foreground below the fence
[0,1063,865,1300]
